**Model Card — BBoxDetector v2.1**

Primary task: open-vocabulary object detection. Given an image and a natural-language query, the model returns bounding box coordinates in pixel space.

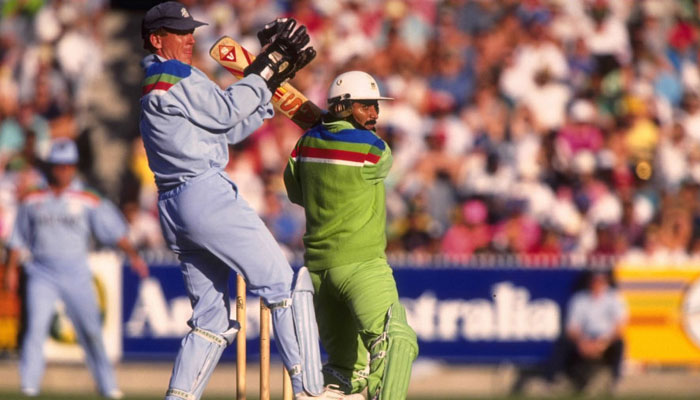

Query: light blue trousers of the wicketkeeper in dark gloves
[158,171,302,398]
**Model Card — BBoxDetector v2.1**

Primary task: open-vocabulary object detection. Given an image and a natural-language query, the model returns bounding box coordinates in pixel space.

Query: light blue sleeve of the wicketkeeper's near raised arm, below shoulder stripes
[160,69,272,134]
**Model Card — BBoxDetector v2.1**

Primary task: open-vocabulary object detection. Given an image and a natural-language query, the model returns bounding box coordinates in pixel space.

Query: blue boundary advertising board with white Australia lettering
[123,264,582,363]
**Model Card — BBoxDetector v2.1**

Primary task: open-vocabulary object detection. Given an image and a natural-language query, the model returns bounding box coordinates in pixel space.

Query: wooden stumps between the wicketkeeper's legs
[236,275,293,400]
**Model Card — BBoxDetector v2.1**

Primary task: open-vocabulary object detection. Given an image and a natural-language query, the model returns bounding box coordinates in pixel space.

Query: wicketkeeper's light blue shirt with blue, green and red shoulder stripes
[140,55,274,192]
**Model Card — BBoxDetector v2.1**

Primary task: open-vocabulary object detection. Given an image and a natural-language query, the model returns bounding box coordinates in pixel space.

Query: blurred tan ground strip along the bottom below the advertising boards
[0,360,700,400]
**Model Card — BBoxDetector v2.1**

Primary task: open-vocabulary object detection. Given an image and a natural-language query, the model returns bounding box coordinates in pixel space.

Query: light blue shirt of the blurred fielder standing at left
[8,188,127,276]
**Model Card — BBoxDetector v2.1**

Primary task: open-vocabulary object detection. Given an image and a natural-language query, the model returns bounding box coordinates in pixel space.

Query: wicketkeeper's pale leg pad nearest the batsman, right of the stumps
[292,267,323,396]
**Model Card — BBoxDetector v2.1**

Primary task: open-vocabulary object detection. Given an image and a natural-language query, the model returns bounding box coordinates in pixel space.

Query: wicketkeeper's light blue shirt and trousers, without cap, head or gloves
[140,55,302,399]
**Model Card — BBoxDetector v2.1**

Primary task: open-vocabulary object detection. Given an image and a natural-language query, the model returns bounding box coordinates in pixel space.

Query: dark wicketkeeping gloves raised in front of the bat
[243,18,316,92]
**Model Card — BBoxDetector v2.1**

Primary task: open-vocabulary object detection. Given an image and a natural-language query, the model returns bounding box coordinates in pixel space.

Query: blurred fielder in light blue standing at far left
[7,139,148,399]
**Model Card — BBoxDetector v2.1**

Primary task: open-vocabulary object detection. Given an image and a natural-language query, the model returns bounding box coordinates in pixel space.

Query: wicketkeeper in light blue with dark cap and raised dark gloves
[140,2,342,400]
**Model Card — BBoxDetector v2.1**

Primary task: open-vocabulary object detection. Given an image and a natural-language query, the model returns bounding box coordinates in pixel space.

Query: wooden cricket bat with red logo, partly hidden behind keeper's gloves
[209,36,322,130]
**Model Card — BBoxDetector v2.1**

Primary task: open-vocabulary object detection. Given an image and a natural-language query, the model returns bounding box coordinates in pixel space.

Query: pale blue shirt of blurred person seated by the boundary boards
[566,289,627,338]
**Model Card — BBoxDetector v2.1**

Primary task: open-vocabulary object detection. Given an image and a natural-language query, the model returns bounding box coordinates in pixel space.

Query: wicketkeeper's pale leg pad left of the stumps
[165,321,238,400]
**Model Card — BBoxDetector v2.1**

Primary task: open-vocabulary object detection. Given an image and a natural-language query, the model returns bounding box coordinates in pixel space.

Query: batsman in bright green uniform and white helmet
[284,71,418,400]
